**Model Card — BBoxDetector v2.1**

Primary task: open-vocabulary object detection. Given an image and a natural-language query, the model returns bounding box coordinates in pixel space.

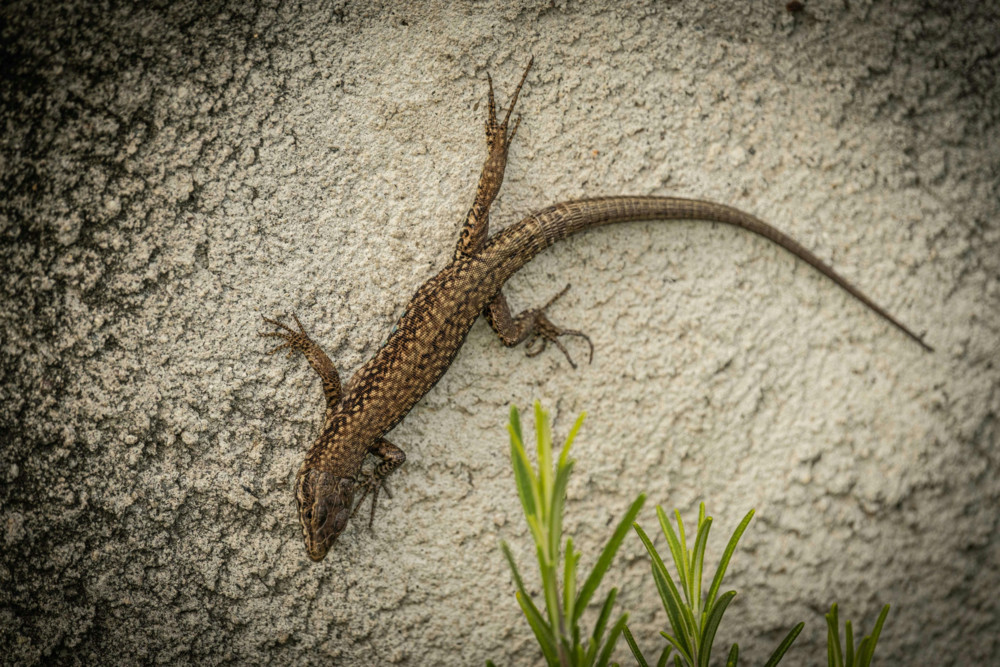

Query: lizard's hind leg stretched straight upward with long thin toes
[455,58,534,259]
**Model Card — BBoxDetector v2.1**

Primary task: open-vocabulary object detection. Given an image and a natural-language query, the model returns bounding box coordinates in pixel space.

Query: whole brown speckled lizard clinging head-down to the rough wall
[260,58,932,561]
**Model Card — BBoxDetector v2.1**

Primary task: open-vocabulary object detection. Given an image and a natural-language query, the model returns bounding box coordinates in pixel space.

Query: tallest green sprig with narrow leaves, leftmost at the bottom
[500,402,646,666]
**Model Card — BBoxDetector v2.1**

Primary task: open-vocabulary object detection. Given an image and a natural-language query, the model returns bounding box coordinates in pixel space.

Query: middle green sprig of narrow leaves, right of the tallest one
[623,503,805,667]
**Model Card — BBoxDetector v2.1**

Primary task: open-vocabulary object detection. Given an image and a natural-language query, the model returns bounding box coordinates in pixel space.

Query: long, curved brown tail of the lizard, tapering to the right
[481,197,934,352]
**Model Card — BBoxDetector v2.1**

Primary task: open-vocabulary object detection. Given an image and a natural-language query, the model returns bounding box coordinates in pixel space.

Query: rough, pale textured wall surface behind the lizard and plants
[0,0,1000,665]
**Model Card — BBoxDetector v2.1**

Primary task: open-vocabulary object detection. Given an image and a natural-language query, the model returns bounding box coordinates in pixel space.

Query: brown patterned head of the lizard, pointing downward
[295,467,355,561]
